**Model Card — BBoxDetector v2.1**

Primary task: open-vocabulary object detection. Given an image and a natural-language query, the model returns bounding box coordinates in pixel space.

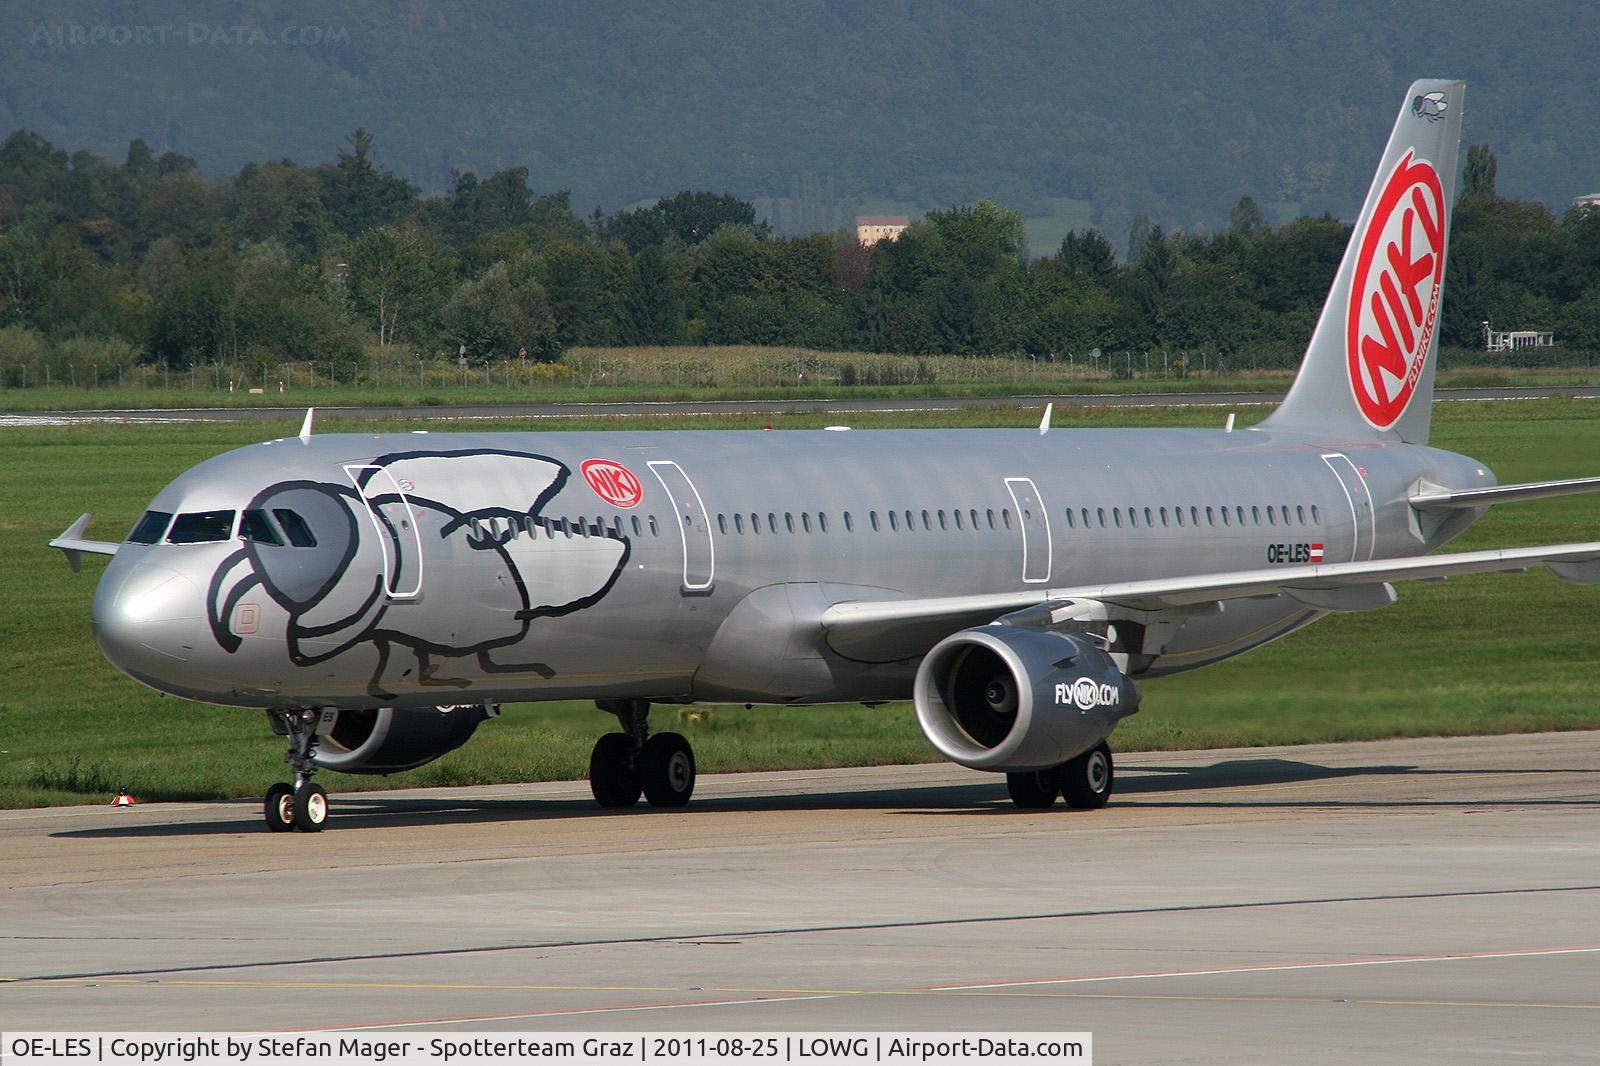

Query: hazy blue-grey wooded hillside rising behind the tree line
[0,0,1600,251]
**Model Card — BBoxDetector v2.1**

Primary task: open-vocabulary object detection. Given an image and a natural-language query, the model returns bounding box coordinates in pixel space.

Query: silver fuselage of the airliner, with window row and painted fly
[94,429,1494,707]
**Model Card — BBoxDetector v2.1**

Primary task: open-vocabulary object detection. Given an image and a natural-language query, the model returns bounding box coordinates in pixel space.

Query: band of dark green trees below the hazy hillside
[0,130,1600,387]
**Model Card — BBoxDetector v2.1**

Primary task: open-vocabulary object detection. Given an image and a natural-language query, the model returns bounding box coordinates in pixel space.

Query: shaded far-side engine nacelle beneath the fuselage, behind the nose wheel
[315,704,491,773]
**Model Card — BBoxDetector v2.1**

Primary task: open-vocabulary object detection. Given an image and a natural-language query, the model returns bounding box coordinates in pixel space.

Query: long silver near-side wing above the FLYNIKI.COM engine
[821,541,1600,659]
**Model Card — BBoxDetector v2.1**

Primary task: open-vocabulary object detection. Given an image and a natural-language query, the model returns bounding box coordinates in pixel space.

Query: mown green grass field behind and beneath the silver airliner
[0,400,1600,807]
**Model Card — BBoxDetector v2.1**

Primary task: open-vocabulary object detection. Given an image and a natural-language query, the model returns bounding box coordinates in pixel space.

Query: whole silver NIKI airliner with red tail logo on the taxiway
[51,80,1600,831]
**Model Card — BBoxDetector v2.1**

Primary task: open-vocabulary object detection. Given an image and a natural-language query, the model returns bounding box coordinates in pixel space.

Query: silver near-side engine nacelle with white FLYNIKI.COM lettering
[915,626,1139,773]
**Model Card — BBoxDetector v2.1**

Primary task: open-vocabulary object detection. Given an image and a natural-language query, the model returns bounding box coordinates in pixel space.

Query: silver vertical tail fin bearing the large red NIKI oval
[1262,80,1466,443]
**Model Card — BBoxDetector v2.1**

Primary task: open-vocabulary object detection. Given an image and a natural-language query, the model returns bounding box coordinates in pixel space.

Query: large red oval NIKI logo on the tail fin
[1344,149,1445,429]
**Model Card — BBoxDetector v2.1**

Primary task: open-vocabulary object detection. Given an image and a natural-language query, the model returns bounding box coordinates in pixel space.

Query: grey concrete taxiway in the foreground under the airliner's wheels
[0,733,1600,1066]
